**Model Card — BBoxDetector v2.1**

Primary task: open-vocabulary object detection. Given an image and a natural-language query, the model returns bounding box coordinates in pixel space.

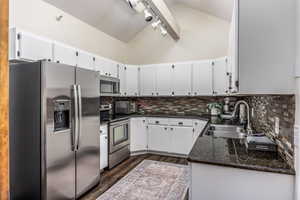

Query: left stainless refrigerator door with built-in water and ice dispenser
[42,62,75,200]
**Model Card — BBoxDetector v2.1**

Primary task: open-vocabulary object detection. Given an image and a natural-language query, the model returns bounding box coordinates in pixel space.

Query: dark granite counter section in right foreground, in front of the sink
[188,123,295,175]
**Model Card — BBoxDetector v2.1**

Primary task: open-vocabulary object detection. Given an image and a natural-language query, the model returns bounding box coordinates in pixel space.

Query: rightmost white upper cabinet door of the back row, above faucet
[212,58,229,95]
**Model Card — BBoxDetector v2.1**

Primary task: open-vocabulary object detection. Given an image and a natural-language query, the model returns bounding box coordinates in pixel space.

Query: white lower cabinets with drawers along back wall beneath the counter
[142,118,207,155]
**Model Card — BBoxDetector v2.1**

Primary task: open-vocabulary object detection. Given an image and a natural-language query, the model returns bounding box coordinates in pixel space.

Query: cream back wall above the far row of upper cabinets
[128,4,230,64]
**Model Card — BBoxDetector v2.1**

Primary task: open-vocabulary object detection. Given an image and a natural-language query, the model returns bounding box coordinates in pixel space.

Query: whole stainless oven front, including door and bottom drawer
[108,119,130,169]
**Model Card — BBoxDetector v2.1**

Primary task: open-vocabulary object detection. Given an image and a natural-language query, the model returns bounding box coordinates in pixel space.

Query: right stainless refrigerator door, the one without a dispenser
[76,68,100,197]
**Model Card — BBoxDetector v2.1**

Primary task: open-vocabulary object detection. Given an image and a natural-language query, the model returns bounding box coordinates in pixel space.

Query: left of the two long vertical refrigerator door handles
[72,85,79,151]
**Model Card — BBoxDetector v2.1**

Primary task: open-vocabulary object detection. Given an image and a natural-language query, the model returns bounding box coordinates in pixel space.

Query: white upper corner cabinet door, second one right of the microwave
[125,65,139,96]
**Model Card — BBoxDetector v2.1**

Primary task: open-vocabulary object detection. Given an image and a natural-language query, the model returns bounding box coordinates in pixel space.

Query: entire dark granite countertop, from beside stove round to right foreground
[99,114,295,175]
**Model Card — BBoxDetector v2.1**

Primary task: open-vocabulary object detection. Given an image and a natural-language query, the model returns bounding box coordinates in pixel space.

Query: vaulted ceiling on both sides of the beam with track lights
[43,0,233,42]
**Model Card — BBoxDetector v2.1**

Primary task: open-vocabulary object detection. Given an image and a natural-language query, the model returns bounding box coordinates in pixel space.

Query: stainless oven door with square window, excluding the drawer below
[109,120,130,153]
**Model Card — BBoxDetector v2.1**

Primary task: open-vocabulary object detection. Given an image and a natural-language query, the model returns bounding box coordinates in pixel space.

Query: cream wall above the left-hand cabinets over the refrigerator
[9,0,128,62]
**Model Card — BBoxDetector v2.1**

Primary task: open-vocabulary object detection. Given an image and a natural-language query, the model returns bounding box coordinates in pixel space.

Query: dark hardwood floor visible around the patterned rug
[80,154,188,200]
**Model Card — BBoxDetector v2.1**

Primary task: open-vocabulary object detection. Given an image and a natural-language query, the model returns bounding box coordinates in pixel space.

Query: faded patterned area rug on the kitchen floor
[97,160,189,200]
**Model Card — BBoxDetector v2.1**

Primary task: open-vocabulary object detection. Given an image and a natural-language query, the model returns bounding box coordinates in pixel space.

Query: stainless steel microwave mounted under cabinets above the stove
[100,76,120,96]
